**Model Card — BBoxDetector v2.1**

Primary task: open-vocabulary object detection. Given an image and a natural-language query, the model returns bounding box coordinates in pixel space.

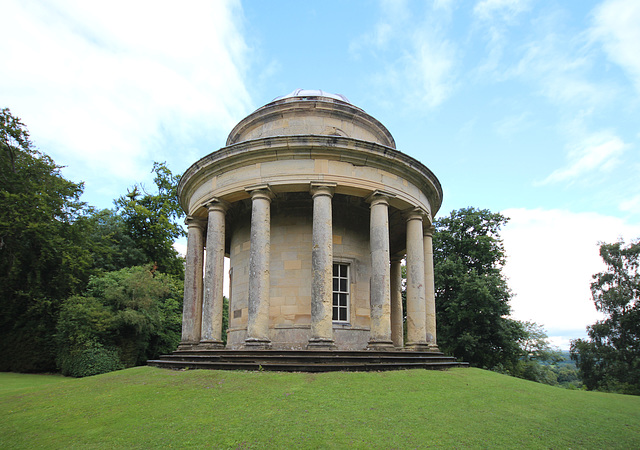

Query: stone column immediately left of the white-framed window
[308,183,335,348]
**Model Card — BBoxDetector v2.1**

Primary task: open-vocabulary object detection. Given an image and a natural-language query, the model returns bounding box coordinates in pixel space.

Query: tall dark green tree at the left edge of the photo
[0,108,91,371]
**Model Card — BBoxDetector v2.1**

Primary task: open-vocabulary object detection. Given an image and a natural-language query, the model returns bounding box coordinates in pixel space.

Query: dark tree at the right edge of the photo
[571,240,640,395]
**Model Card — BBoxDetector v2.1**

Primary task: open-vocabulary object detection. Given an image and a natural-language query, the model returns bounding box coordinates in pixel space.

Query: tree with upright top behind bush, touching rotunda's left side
[115,162,185,276]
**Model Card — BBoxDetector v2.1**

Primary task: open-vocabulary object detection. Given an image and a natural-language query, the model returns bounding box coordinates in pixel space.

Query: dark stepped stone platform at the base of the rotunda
[147,349,468,372]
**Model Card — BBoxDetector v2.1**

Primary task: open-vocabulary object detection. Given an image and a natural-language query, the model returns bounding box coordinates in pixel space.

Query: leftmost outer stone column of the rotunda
[180,217,204,347]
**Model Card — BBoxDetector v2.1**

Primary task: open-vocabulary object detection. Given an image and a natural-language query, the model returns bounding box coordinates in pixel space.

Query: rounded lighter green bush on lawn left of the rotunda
[57,266,183,376]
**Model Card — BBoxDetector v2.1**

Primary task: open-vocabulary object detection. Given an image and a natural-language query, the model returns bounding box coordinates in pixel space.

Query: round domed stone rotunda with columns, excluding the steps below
[178,89,442,352]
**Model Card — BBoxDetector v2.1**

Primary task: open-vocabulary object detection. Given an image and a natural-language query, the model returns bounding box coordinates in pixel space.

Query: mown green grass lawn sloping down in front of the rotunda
[0,367,640,449]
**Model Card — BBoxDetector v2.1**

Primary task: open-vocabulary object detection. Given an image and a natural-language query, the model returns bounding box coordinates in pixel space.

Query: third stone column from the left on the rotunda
[245,185,273,348]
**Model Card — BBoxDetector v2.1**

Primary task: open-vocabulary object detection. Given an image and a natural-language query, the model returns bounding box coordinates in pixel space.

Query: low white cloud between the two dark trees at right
[501,209,640,348]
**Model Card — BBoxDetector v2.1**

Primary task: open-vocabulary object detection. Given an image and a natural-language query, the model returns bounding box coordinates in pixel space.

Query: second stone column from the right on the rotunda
[405,208,428,351]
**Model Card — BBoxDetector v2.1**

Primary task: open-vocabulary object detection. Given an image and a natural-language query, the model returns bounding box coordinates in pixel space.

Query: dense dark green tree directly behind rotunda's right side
[433,208,526,370]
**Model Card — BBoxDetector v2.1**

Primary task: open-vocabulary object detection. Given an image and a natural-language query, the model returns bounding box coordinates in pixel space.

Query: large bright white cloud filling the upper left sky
[0,0,251,207]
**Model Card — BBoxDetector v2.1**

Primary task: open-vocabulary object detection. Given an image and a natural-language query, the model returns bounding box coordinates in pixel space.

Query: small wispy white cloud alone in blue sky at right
[540,132,629,184]
